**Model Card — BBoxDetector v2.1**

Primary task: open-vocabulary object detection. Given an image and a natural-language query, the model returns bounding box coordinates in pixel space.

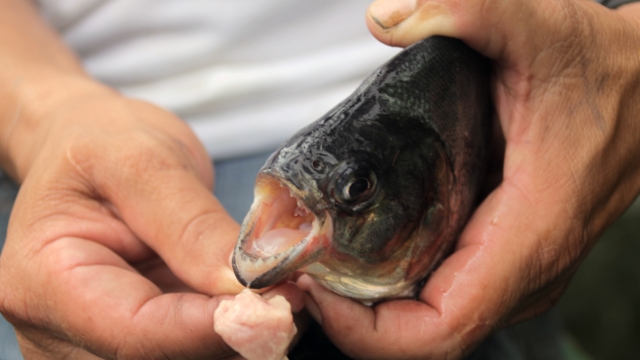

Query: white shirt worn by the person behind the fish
[38,0,398,158]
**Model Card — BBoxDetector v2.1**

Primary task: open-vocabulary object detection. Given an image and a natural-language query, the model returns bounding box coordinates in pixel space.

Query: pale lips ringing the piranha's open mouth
[231,171,333,289]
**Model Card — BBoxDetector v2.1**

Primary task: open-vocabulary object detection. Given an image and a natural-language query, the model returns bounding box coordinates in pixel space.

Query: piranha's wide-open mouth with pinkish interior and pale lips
[232,173,333,289]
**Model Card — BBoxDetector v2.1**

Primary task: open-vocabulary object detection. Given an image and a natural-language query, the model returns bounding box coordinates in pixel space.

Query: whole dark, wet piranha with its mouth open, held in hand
[232,37,491,303]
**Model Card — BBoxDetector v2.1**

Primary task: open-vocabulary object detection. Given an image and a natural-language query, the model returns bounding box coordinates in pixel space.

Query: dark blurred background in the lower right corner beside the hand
[558,198,640,360]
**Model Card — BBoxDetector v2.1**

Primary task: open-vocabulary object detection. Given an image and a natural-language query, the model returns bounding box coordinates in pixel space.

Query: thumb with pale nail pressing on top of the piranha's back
[367,0,572,59]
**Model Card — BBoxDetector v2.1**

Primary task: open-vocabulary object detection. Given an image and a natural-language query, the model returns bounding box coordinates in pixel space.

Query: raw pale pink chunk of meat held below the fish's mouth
[214,289,297,360]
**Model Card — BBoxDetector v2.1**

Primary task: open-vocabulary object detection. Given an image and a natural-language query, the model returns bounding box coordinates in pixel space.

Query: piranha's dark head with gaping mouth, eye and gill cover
[232,116,451,302]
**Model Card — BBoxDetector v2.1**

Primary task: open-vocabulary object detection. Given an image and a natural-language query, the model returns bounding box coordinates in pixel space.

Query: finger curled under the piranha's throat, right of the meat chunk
[298,276,461,359]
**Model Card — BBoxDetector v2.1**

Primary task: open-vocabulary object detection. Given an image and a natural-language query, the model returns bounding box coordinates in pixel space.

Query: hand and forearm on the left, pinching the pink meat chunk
[0,0,302,359]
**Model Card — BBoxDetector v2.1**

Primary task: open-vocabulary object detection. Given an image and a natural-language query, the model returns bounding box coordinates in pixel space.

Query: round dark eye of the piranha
[334,168,376,206]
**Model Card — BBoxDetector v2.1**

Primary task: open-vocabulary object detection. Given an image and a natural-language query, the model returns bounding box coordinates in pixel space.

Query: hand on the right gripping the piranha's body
[298,0,640,360]
